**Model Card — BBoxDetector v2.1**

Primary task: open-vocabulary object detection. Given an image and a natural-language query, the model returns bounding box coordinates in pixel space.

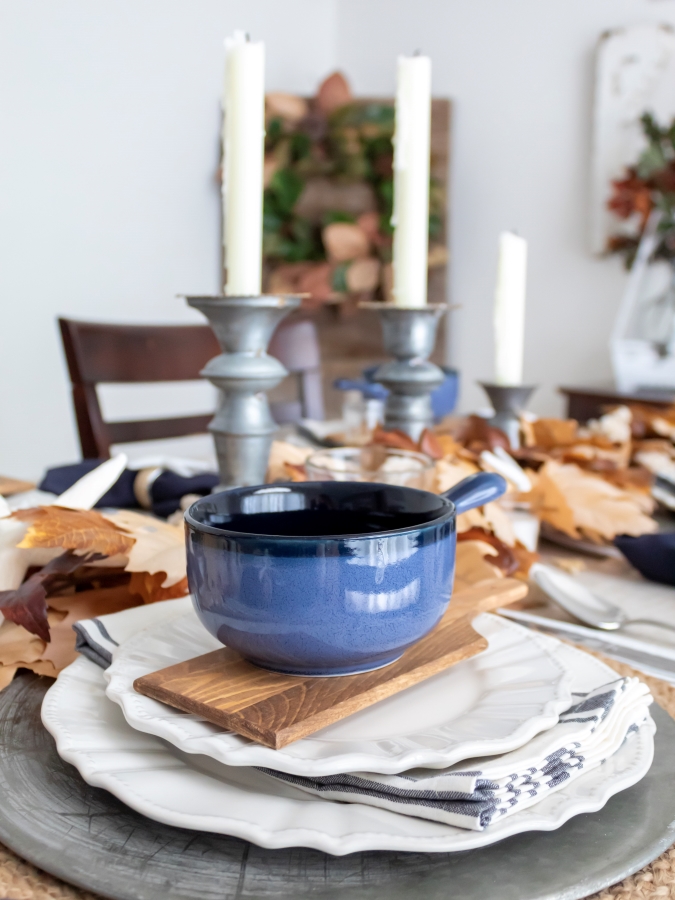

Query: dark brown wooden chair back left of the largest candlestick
[59,319,220,459]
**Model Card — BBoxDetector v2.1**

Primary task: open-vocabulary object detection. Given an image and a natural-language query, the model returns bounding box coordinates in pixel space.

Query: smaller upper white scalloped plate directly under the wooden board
[105,612,571,776]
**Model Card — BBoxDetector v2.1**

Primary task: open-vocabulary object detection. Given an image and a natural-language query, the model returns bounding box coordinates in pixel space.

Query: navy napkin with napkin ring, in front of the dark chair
[39,459,219,517]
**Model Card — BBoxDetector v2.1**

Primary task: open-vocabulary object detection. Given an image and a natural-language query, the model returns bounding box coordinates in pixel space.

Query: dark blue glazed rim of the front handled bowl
[184,481,455,543]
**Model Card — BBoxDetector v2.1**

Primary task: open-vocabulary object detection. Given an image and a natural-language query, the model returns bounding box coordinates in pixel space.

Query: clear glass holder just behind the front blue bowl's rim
[305,444,434,491]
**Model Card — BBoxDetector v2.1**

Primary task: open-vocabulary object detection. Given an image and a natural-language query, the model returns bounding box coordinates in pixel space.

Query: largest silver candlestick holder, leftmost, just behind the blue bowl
[186,296,301,489]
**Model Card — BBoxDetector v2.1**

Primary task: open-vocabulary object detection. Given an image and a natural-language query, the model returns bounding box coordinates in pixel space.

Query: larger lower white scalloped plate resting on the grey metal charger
[42,641,654,855]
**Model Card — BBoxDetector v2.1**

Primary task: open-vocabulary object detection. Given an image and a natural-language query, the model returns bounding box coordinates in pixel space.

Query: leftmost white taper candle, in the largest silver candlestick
[223,31,265,296]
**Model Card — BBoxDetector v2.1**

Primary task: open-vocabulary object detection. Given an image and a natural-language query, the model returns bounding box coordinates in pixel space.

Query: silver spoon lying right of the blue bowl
[530,563,675,631]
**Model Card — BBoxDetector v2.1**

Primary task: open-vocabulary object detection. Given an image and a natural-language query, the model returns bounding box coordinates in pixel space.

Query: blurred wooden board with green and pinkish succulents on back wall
[254,72,450,419]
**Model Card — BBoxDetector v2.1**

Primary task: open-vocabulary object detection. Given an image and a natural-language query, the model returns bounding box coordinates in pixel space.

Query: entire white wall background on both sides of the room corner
[0,0,675,486]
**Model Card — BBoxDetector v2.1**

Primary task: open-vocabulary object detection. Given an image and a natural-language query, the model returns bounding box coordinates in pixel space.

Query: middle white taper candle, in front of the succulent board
[392,56,431,306]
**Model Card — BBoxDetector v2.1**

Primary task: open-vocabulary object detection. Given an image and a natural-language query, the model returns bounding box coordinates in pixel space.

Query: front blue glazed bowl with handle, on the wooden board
[185,472,506,675]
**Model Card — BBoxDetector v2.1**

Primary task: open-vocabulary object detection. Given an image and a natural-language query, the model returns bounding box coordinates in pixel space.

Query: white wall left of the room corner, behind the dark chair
[0,0,336,477]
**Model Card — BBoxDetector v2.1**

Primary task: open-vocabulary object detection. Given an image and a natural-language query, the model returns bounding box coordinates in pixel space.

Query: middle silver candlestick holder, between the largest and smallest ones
[361,303,448,441]
